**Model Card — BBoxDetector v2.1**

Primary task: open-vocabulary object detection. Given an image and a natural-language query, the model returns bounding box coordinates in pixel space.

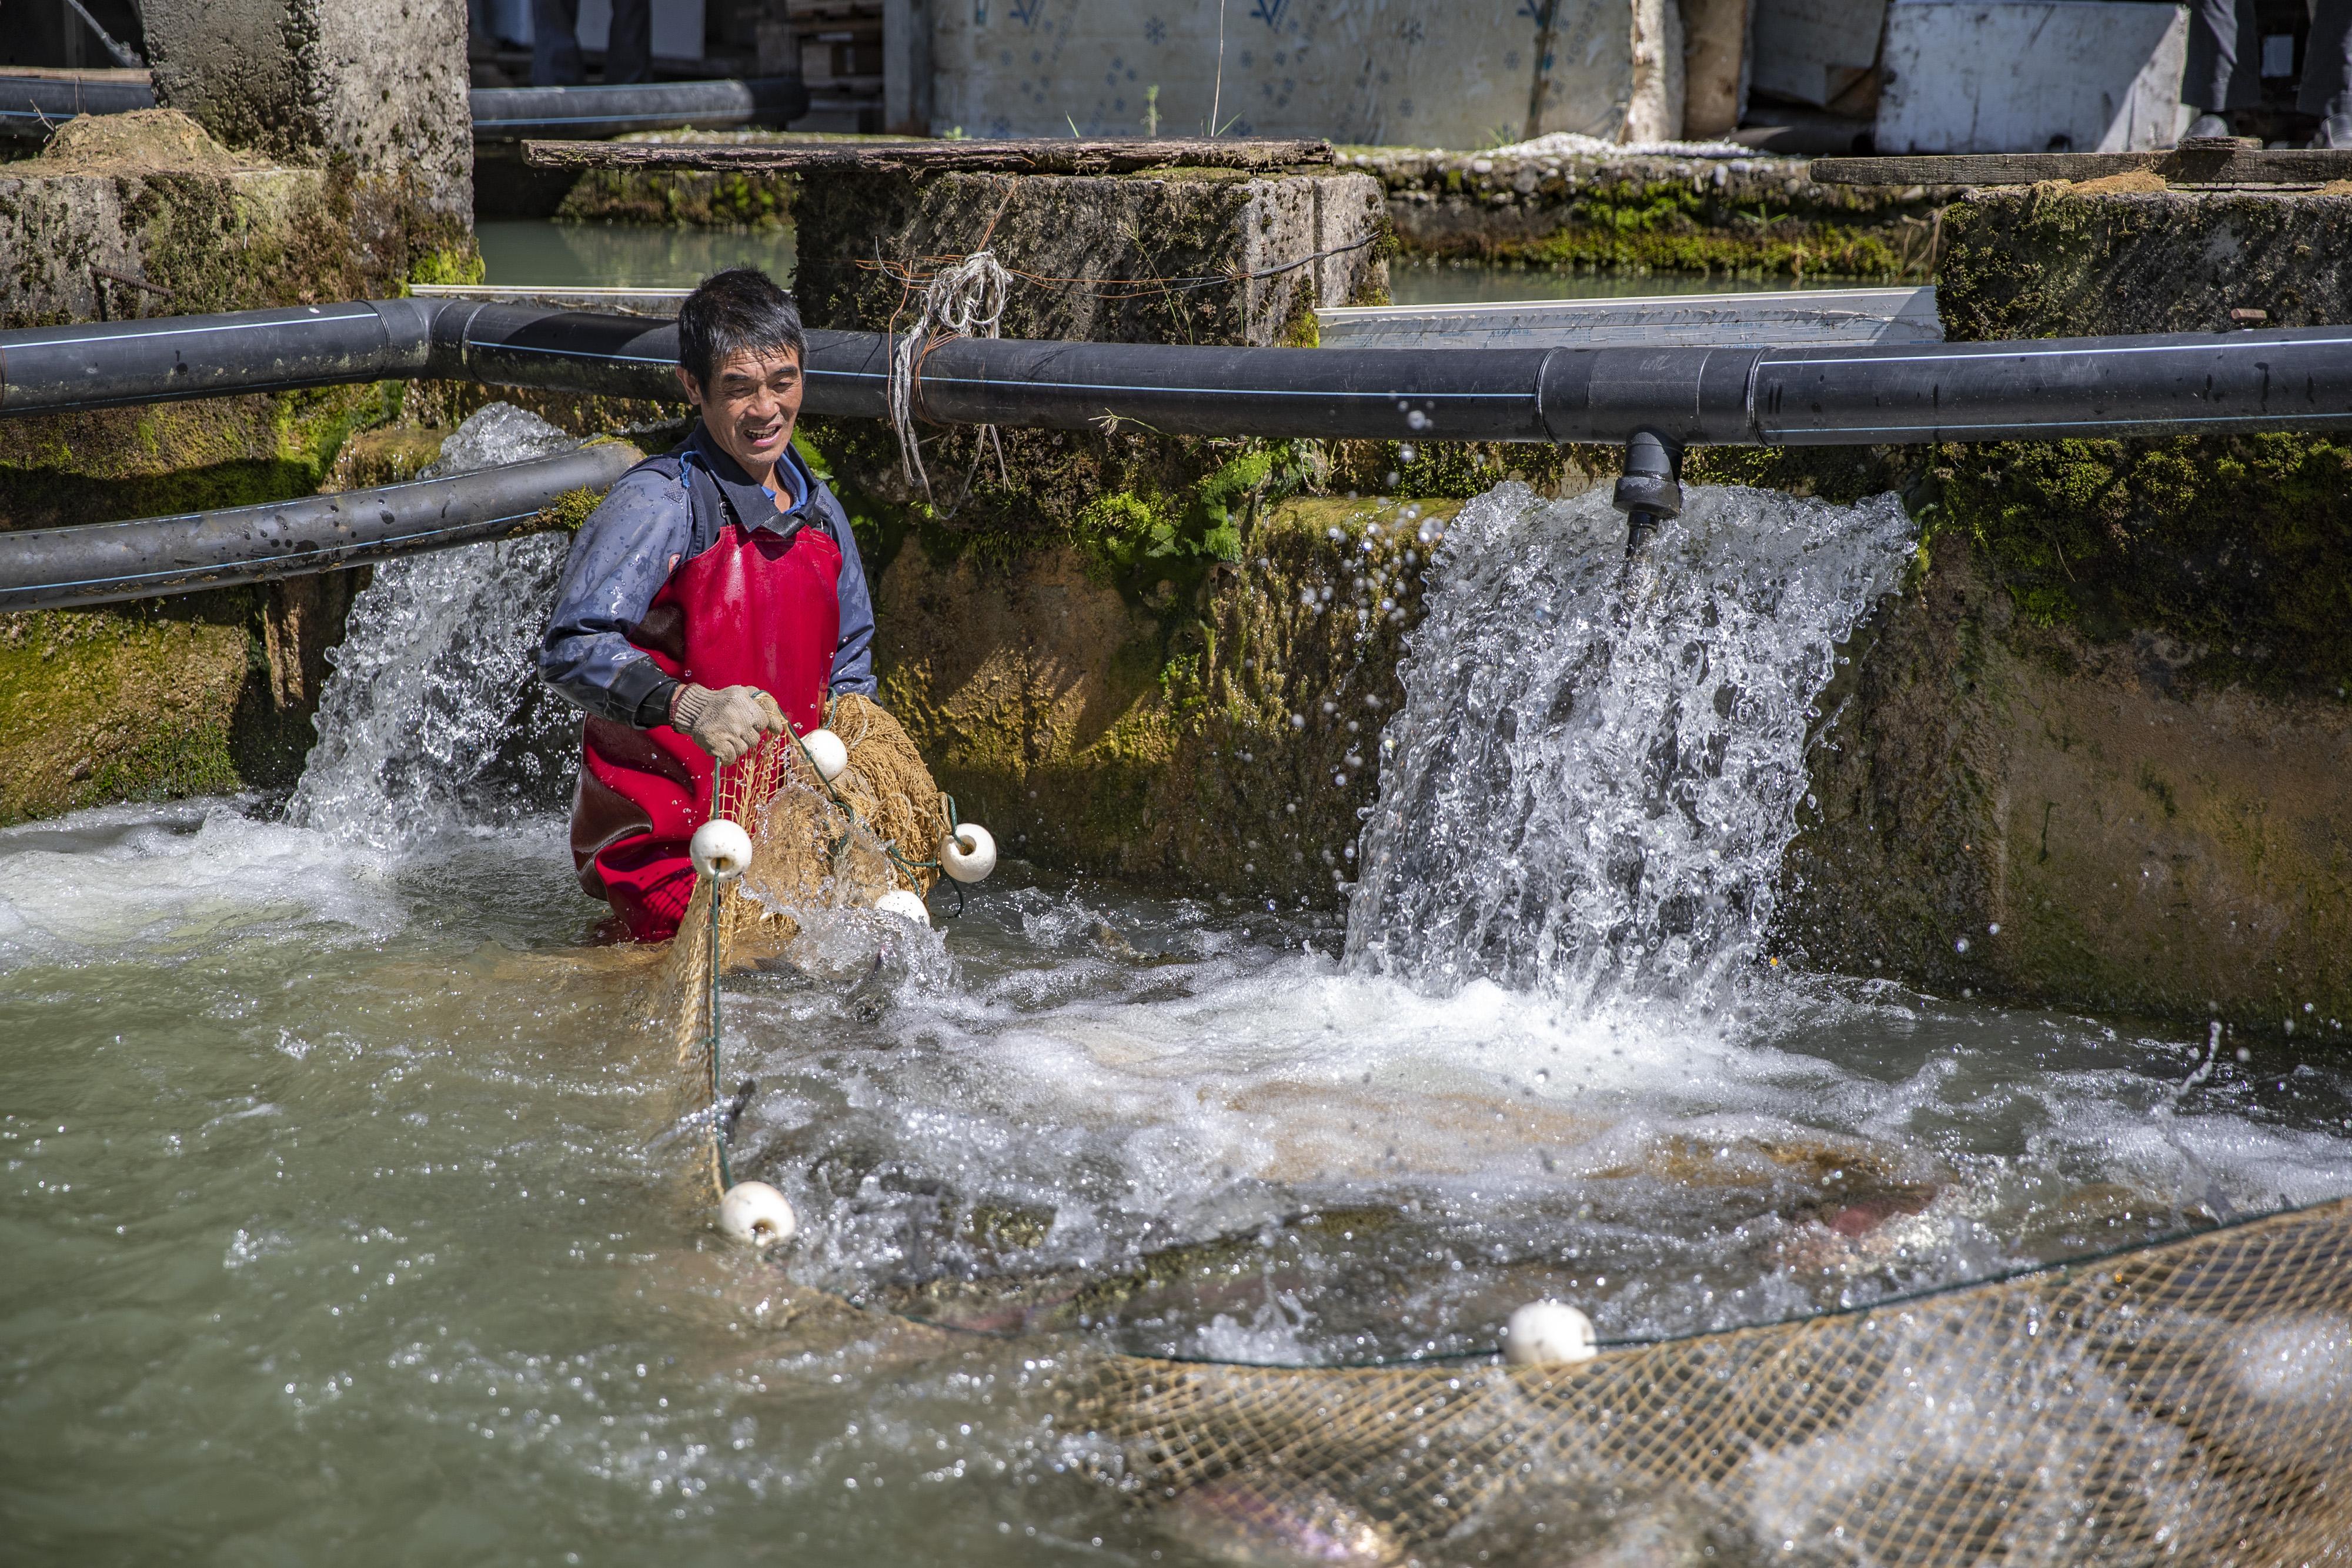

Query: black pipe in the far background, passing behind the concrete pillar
[0,75,809,141]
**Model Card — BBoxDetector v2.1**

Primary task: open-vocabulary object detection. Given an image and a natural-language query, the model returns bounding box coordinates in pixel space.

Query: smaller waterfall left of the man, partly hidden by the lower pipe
[287,402,579,848]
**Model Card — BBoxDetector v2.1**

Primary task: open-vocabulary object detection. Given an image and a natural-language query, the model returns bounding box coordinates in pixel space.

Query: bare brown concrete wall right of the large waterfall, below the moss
[1780,536,2352,1032]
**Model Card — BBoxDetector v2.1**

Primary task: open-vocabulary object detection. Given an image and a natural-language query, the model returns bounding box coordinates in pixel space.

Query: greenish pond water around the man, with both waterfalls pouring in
[0,446,2352,1566]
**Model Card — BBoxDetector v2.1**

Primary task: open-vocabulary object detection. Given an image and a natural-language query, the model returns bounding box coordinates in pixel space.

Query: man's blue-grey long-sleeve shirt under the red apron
[539,426,875,729]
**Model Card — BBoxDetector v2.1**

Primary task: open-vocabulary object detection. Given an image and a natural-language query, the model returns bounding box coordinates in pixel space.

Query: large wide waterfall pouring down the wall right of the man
[1348,484,1912,1004]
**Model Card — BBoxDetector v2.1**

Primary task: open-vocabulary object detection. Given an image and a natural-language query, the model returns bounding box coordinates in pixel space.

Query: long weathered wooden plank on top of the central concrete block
[522,136,1331,174]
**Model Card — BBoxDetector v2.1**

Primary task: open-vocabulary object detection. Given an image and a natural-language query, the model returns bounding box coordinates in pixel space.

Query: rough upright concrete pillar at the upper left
[143,0,473,280]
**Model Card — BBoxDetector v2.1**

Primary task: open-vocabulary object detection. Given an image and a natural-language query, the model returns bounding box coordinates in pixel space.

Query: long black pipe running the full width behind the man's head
[0,299,2352,447]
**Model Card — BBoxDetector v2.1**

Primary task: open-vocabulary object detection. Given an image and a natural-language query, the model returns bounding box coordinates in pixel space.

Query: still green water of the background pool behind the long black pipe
[473,219,1853,306]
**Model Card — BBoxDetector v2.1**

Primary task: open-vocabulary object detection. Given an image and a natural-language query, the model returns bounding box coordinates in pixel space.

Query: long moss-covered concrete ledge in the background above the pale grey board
[1341,148,1959,282]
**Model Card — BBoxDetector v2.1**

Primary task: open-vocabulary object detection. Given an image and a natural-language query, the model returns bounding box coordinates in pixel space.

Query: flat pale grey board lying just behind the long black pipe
[1315,289,1943,348]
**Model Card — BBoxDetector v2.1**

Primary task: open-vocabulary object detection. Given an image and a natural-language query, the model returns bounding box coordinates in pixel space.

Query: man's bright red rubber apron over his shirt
[572,520,842,942]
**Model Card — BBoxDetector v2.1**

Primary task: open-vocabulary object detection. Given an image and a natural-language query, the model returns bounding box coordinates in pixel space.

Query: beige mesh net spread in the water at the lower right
[1080,1201,2352,1563]
